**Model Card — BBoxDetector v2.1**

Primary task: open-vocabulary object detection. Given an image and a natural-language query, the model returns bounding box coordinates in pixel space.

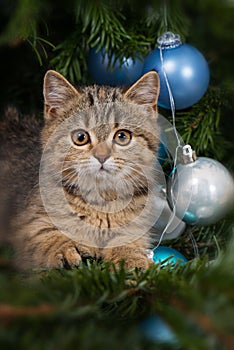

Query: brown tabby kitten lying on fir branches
[2,71,159,268]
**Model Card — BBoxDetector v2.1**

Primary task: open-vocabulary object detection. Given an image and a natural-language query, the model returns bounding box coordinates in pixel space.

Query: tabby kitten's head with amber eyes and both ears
[43,71,158,208]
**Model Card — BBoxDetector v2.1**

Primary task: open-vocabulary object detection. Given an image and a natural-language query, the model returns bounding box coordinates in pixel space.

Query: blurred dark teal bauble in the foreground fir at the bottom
[140,315,178,346]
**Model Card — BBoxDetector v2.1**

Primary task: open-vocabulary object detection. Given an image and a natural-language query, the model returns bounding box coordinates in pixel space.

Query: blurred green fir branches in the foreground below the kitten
[0,242,234,350]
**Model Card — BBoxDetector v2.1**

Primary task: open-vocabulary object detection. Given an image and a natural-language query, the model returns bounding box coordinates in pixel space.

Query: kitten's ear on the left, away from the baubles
[43,70,80,114]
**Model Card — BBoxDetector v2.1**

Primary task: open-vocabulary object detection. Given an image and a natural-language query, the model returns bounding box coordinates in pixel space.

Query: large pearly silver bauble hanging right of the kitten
[168,157,234,226]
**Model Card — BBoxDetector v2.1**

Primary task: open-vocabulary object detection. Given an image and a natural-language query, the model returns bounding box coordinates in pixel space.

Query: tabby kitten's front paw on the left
[48,245,82,267]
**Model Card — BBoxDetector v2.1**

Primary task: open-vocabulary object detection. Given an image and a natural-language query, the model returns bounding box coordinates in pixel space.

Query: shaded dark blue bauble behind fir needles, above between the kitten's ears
[88,48,143,86]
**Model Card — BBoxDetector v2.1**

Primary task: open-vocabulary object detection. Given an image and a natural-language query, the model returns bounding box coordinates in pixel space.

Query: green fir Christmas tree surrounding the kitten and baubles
[0,0,234,350]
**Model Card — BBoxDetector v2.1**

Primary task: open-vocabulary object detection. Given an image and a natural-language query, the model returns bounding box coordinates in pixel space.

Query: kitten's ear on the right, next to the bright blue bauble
[125,71,160,109]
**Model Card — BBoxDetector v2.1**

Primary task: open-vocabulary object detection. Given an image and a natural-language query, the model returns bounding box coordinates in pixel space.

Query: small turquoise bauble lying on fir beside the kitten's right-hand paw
[149,246,187,266]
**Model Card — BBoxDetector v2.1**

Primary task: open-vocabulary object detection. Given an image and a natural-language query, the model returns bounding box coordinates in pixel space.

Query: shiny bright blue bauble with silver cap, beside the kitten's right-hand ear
[142,32,210,109]
